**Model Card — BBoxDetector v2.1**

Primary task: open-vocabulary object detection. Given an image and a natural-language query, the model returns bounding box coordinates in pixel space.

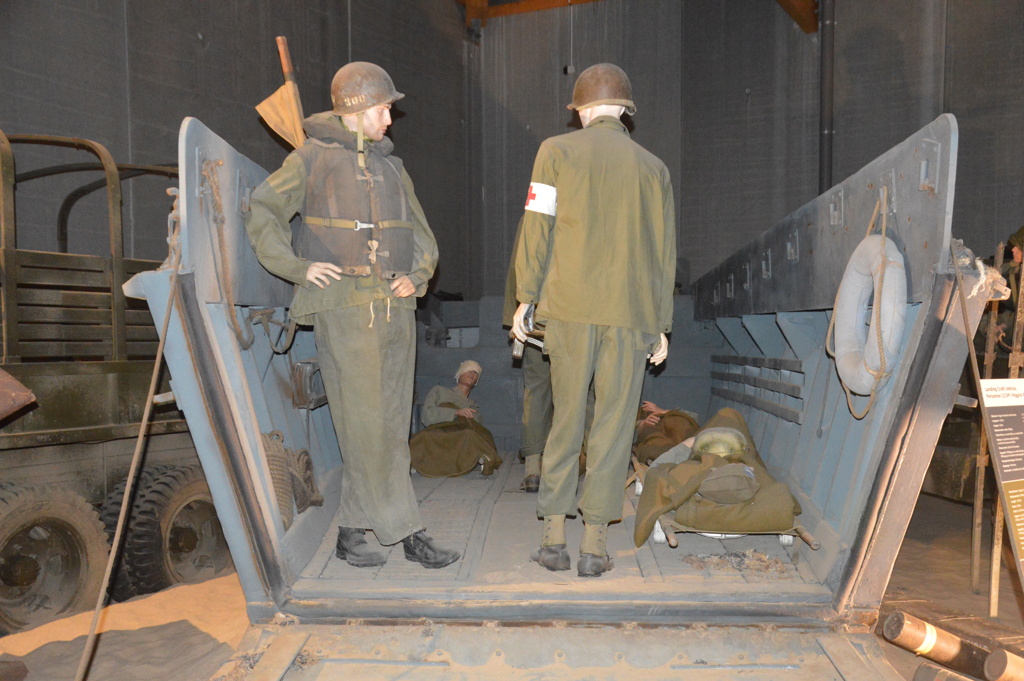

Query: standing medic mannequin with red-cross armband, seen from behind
[512,63,676,577]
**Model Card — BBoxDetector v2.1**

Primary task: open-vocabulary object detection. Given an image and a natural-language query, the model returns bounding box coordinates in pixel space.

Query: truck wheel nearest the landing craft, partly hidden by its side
[125,466,234,593]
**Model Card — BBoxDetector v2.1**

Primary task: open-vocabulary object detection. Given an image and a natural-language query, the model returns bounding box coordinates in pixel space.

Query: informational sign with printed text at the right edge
[981,379,1024,584]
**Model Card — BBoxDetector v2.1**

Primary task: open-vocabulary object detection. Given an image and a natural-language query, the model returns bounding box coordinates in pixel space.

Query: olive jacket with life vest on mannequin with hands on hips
[246,112,437,324]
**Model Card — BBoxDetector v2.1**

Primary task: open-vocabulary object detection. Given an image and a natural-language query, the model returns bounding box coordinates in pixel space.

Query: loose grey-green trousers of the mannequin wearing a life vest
[313,300,423,545]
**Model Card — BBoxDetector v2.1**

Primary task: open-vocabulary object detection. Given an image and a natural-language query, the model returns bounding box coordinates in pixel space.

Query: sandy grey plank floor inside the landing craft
[293,454,831,604]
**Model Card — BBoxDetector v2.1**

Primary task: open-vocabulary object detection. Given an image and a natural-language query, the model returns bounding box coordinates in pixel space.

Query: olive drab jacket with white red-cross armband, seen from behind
[515,116,676,335]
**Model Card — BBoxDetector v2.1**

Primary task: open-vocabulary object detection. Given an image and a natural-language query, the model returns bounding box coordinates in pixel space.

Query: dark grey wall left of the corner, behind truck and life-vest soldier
[0,0,465,284]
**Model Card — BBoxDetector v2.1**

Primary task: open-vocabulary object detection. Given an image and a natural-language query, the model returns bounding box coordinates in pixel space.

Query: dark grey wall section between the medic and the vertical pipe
[677,0,815,288]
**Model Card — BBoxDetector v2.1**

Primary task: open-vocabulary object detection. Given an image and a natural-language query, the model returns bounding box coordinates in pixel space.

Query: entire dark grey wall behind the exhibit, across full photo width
[0,0,1024,299]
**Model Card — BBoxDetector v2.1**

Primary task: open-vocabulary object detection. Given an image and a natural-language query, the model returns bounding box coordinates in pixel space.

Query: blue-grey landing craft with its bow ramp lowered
[126,115,998,681]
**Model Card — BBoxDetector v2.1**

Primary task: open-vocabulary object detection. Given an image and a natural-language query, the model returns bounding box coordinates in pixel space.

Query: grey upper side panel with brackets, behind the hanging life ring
[692,115,956,318]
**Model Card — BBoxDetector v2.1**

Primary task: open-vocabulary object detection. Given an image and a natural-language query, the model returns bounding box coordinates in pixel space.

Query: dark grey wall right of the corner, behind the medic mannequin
[466,0,1024,293]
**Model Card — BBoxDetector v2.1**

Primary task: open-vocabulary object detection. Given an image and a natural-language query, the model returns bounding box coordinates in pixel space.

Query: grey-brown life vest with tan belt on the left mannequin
[295,138,413,280]
